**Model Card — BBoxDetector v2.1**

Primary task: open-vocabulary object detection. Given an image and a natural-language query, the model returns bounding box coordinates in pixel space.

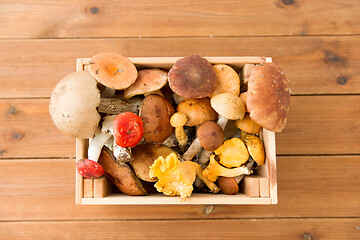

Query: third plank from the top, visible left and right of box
[0,96,360,158]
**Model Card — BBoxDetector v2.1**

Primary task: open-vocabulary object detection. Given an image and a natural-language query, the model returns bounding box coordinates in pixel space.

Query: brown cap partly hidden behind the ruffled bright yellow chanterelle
[130,143,174,182]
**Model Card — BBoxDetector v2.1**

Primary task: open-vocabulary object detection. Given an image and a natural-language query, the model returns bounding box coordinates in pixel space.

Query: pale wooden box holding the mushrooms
[76,57,277,205]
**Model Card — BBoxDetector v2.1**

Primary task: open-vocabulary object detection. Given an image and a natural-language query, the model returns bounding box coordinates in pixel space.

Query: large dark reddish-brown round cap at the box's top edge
[168,55,217,98]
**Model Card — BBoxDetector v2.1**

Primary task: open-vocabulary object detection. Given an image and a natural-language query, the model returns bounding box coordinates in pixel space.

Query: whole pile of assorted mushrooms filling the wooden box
[49,53,290,200]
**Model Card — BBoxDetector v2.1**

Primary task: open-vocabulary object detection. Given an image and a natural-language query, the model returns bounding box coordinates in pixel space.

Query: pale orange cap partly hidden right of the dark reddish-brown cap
[210,64,240,97]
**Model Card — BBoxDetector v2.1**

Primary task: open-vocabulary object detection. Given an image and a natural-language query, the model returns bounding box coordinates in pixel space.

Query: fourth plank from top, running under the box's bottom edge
[0,156,360,221]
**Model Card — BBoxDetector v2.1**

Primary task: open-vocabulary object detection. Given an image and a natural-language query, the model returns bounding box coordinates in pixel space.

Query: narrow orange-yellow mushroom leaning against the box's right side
[242,134,265,165]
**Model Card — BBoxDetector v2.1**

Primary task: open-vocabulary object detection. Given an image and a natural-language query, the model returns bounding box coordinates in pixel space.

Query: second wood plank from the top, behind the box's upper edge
[0,35,360,98]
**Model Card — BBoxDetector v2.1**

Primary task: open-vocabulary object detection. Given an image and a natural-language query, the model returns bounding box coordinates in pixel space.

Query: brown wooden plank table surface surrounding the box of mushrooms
[0,0,360,240]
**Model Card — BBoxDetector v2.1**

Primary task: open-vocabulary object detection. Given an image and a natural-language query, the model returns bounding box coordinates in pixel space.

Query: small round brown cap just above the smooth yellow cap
[196,121,224,151]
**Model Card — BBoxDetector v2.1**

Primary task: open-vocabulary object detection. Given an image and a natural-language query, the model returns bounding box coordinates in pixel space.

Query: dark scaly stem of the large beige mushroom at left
[98,97,143,115]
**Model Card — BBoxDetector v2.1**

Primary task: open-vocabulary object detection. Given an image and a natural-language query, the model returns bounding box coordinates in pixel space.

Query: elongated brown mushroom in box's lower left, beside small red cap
[99,147,147,196]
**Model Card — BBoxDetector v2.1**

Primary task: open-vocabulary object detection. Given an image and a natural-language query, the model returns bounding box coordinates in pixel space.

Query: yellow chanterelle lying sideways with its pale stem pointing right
[202,155,251,182]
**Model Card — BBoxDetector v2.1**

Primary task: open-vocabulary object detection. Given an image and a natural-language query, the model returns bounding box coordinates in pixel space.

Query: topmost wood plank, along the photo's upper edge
[0,0,360,38]
